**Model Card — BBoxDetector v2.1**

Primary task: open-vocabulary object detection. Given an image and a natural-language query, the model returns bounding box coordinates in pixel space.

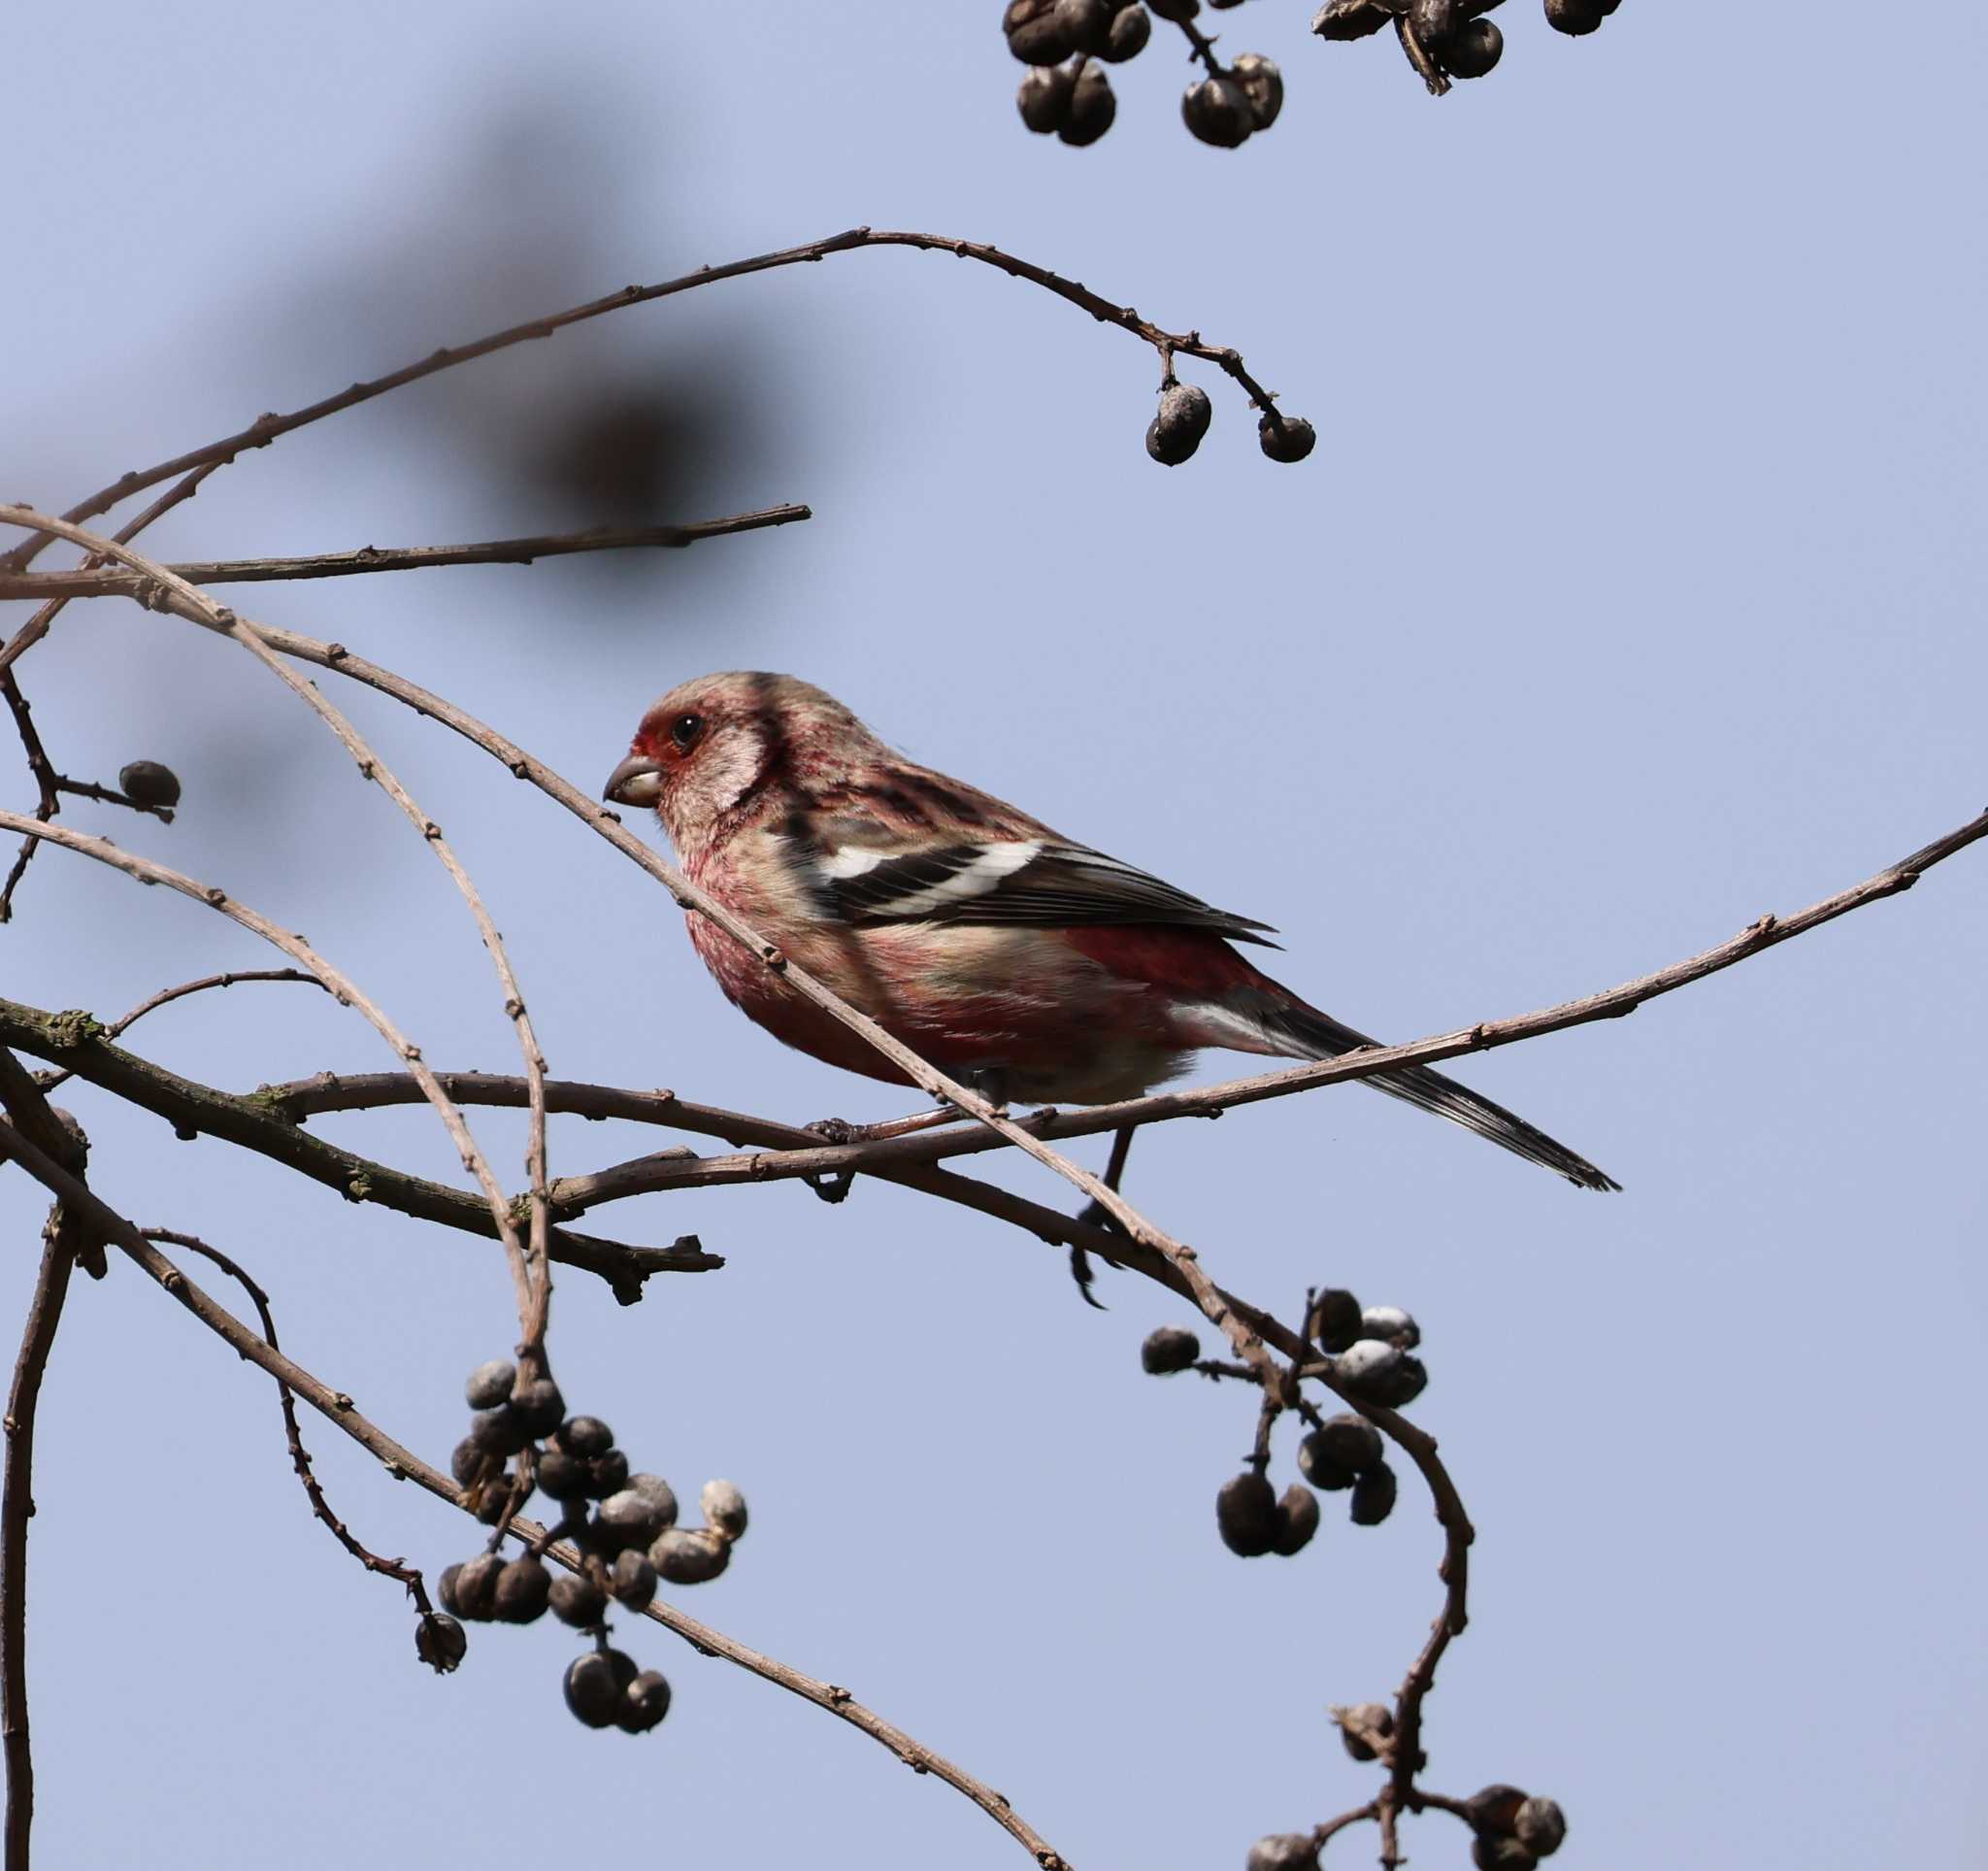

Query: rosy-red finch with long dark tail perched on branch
[605,672,1620,1189]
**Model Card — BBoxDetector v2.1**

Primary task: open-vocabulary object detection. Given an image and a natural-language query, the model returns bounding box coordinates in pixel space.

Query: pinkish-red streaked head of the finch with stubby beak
[603,670,875,855]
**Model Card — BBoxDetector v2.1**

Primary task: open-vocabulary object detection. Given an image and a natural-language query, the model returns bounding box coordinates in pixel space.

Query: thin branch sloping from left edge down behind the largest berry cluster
[0,1123,1070,1871]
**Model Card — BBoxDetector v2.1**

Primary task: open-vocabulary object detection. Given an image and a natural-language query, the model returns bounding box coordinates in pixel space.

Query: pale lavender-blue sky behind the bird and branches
[0,0,1988,1871]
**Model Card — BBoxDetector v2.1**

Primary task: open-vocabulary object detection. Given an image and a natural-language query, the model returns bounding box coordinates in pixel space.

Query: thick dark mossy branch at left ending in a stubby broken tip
[0,1000,726,1304]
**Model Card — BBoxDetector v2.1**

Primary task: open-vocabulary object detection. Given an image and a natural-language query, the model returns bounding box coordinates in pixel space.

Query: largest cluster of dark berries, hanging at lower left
[440,1358,746,1734]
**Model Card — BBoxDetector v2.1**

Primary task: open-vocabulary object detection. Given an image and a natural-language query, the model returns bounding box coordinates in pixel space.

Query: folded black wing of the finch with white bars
[810,835,1276,949]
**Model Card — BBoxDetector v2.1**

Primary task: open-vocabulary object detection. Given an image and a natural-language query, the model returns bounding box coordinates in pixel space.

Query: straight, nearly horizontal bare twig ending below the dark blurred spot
[0,505,815,600]
